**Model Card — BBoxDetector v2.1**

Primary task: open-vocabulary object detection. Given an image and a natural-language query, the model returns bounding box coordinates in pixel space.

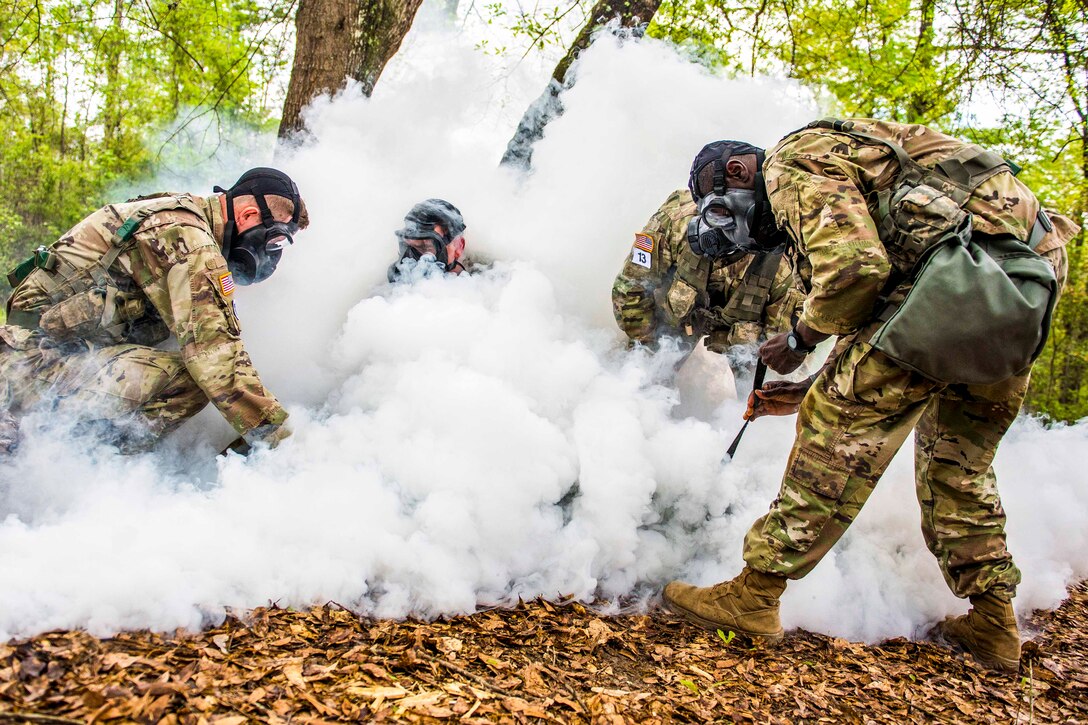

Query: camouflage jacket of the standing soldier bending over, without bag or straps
[764,119,1064,335]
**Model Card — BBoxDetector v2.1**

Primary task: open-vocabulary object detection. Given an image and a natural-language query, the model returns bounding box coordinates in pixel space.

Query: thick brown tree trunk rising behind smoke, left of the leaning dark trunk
[280,0,423,138]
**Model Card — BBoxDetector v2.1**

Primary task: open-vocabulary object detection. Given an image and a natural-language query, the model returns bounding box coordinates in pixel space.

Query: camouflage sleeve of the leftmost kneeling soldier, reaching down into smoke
[128,210,287,434]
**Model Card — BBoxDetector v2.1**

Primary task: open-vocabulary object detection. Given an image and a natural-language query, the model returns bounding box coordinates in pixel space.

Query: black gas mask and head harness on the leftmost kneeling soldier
[214,168,302,284]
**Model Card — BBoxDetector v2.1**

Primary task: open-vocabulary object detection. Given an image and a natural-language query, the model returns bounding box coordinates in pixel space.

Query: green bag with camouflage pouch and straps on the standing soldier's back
[808,119,1059,384]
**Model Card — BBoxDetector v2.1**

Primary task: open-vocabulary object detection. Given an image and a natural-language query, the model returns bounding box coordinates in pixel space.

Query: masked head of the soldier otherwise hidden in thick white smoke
[387,199,467,282]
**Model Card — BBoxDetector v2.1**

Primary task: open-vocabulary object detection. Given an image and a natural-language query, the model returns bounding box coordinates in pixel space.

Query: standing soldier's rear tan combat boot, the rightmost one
[932,592,1019,673]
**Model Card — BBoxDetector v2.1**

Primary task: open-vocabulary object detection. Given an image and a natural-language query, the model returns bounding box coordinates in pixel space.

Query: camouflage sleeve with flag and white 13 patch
[611,188,694,344]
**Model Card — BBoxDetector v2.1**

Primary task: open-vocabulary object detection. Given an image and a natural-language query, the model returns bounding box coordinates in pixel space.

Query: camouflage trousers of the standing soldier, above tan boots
[744,336,1028,598]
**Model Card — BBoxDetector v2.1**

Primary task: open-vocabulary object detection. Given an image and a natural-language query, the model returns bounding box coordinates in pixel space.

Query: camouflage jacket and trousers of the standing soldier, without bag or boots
[744,120,1075,597]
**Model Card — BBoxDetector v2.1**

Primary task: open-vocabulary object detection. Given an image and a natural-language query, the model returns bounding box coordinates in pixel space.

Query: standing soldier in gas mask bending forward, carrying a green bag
[664,120,1076,671]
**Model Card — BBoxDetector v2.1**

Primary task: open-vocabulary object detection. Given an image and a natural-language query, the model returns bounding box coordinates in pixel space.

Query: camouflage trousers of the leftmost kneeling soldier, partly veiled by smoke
[0,325,208,450]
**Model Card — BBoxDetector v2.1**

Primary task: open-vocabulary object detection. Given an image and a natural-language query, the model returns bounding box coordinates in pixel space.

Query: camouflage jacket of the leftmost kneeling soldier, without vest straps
[10,195,287,434]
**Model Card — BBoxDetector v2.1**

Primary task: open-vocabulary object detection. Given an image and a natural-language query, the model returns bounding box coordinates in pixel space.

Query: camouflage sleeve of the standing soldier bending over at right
[764,133,891,334]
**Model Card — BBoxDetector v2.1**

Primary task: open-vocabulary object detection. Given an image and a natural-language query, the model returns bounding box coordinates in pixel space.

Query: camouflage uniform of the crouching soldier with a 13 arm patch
[613,188,802,353]
